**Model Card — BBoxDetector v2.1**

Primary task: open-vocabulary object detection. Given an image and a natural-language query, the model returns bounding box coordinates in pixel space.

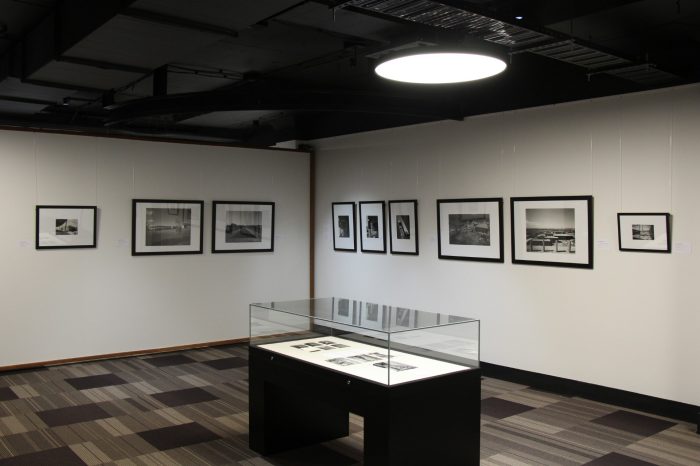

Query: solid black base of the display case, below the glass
[249,346,481,466]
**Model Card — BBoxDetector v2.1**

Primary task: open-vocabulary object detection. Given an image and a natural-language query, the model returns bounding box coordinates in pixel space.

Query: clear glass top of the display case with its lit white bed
[250,298,479,385]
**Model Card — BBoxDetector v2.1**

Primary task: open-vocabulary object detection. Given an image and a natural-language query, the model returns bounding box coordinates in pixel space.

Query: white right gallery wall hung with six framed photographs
[314,85,700,405]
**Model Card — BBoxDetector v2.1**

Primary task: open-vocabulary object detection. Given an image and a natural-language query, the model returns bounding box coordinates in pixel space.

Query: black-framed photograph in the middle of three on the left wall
[131,199,204,256]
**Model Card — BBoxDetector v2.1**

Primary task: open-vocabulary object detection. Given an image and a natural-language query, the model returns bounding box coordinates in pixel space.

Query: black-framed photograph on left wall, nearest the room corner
[211,201,275,253]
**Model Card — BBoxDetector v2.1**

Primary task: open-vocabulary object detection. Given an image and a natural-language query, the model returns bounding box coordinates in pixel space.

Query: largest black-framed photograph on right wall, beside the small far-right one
[510,196,593,269]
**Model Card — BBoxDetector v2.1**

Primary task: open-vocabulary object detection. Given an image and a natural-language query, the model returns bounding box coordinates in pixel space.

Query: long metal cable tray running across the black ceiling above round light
[341,0,677,85]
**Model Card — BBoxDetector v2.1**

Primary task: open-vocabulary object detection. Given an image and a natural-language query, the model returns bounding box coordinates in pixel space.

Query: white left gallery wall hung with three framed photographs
[0,131,309,366]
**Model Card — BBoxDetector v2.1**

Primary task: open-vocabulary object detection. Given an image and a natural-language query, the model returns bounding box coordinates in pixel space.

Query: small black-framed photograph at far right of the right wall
[617,213,671,252]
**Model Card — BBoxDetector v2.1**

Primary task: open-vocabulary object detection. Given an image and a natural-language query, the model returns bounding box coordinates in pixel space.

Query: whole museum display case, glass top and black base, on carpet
[248,298,481,466]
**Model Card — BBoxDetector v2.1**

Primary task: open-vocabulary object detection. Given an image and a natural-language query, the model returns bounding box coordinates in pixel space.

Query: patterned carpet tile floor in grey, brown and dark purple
[0,345,700,466]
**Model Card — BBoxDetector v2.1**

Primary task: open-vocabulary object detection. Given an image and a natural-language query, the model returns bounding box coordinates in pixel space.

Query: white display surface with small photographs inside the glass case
[258,336,470,385]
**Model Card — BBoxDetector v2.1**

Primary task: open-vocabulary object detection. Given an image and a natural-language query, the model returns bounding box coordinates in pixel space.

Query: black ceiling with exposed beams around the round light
[0,0,700,146]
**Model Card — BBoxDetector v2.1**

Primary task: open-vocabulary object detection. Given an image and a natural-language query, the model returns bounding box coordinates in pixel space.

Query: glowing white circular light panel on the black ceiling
[374,52,506,84]
